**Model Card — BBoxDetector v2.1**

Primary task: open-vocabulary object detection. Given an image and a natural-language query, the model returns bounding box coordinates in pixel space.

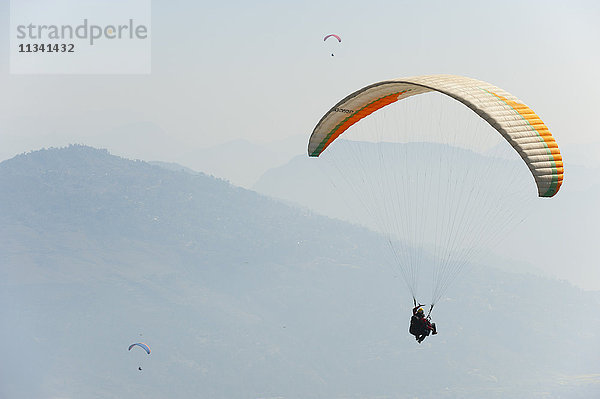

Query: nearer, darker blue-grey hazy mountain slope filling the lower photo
[0,146,600,398]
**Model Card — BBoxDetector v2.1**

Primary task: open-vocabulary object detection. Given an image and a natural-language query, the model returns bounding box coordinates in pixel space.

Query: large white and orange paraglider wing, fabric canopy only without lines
[308,74,563,197]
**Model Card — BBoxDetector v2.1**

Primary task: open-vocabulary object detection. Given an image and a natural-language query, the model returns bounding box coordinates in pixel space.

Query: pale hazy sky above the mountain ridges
[0,0,600,161]
